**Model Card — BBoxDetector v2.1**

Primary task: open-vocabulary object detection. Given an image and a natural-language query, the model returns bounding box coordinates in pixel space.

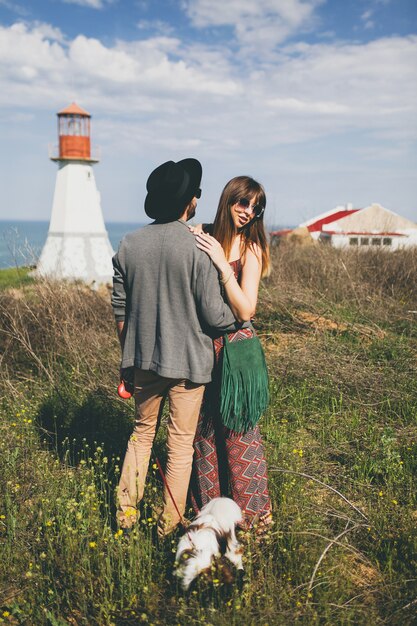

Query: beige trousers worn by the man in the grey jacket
[117,369,204,535]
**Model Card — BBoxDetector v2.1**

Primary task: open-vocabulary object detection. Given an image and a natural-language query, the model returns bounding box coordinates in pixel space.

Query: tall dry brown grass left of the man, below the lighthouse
[0,281,118,388]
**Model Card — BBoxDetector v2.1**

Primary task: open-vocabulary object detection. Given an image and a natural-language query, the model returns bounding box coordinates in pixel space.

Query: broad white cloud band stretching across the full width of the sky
[0,21,417,158]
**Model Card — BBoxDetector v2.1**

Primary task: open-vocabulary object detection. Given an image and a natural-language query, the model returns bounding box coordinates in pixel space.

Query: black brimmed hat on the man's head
[145,159,203,221]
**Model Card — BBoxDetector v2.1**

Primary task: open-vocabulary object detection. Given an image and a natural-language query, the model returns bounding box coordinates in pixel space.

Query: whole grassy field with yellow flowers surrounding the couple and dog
[0,246,417,626]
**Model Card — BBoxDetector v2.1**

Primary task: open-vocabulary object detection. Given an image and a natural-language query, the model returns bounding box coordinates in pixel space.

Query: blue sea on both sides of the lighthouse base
[0,220,144,269]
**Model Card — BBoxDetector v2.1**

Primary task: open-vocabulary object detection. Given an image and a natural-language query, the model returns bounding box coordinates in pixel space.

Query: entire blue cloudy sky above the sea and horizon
[0,0,417,226]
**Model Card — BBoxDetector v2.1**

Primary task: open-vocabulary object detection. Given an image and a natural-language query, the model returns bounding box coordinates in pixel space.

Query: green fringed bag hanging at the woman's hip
[220,335,269,433]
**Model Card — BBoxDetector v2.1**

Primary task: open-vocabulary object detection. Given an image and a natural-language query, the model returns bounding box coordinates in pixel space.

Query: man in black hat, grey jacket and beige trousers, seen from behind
[112,159,236,536]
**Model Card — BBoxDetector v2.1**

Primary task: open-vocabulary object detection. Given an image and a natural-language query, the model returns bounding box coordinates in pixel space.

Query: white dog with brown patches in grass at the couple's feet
[174,498,243,590]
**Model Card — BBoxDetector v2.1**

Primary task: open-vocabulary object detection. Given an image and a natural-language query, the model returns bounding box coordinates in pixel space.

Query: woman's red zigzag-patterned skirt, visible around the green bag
[190,328,272,529]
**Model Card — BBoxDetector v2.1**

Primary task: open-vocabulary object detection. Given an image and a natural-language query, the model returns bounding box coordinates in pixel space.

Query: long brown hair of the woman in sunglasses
[213,176,271,277]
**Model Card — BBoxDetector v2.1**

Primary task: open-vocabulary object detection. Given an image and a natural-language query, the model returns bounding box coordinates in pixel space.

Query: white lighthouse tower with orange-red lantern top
[36,103,114,285]
